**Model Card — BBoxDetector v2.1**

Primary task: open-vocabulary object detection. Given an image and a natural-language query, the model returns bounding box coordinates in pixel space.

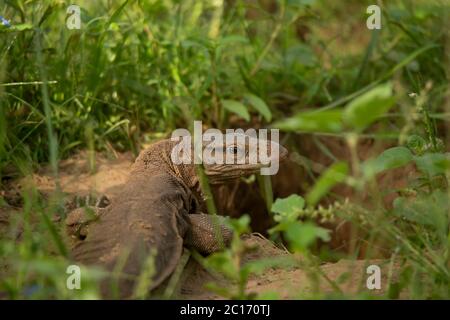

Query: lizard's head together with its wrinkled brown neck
[133,131,288,189]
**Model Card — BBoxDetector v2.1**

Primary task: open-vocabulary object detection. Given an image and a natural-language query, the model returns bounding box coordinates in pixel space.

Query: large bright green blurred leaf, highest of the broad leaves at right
[344,83,395,131]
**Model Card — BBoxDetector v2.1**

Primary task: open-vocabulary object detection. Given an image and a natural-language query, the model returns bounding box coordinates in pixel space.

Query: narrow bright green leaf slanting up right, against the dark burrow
[306,162,348,206]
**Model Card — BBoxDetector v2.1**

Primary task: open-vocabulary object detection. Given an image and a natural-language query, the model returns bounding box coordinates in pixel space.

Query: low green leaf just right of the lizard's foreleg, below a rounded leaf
[285,221,330,252]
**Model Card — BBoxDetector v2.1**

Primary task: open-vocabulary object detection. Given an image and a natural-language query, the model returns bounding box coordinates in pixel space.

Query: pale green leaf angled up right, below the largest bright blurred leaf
[362,147,413,179]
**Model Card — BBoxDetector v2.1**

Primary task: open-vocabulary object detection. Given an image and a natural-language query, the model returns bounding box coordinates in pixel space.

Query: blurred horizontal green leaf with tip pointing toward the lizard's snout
[272,109,342,132]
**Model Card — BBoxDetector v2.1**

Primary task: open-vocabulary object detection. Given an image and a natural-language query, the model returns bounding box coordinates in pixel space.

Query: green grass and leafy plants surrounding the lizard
[0,0,450,299]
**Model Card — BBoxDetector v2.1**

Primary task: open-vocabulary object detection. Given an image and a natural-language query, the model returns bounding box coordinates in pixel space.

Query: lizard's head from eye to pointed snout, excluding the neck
[203,133,288,184]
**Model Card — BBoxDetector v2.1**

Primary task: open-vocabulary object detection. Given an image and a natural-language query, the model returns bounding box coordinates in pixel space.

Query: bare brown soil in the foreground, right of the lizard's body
[177,234,398,300]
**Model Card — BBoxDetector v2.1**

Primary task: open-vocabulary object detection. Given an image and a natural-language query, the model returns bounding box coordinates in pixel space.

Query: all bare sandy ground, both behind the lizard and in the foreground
[0,153,395,299]
